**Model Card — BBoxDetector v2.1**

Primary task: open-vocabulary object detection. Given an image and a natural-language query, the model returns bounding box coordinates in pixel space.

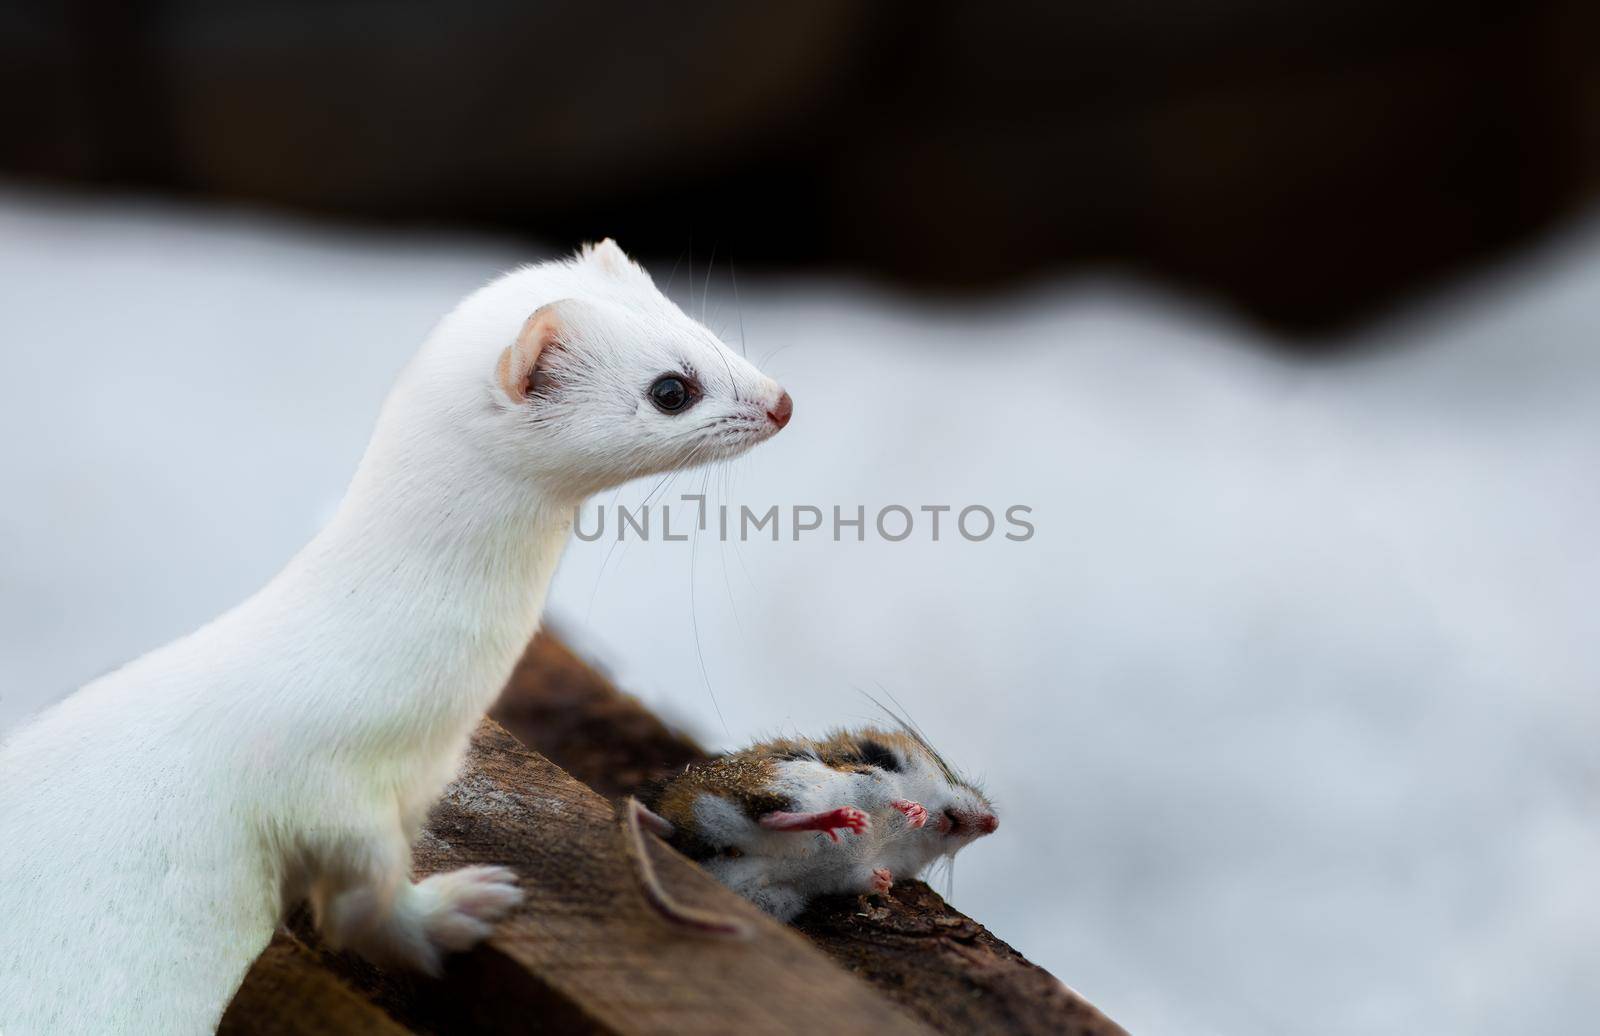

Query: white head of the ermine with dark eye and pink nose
[425,240,794,497]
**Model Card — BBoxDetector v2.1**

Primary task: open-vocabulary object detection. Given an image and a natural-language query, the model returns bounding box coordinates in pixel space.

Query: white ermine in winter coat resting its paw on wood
[0,240,792,1036]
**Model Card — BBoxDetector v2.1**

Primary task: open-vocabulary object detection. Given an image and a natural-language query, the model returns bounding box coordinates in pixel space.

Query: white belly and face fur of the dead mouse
[694,750,994,921]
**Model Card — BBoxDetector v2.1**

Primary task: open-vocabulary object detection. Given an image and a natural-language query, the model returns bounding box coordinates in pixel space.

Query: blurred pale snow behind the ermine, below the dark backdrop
[0,190,1600,1036]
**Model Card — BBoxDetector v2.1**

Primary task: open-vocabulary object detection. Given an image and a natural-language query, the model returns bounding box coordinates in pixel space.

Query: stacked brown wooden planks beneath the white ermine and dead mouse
[221,635,1122,1036]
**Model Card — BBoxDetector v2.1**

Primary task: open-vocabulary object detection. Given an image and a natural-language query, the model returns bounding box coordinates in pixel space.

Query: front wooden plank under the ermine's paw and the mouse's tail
[300,719,928,1036]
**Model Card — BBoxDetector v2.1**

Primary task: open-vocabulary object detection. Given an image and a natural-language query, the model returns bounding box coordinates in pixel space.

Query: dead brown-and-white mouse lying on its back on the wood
[627,727,1000,934]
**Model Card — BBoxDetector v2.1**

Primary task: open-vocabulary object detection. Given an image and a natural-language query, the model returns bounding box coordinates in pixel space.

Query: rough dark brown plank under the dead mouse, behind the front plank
[494,635,1123,1036]
